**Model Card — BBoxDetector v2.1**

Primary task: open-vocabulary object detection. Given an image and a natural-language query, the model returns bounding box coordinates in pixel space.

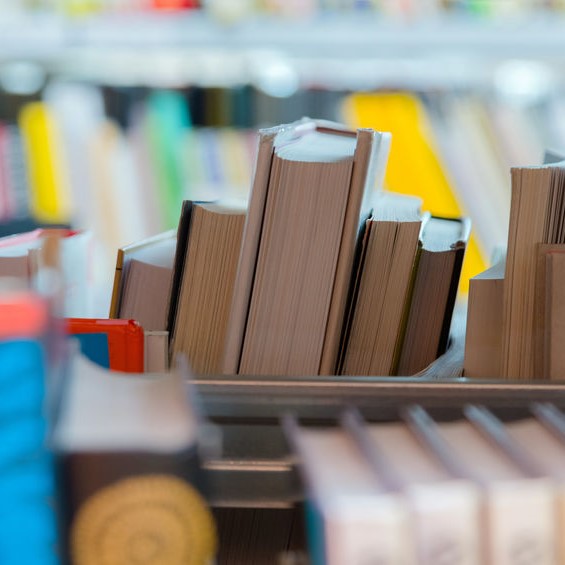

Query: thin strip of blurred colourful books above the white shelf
[4,0,563,17]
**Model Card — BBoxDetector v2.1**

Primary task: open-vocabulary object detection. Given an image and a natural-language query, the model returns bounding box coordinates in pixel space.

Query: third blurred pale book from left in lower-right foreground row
[405,407,555,565]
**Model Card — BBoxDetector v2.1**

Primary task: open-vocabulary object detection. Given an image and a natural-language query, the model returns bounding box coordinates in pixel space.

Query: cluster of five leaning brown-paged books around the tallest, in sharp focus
[111,119,469,376]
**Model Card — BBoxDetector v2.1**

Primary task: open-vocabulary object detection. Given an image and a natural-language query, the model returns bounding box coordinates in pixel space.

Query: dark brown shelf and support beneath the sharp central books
[195,377,565,508]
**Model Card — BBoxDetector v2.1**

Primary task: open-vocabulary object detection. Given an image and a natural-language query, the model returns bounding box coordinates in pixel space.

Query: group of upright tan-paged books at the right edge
[465,158,565,380]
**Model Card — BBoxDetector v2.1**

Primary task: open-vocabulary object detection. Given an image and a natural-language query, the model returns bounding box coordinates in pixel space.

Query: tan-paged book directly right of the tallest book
[340,193,422,376]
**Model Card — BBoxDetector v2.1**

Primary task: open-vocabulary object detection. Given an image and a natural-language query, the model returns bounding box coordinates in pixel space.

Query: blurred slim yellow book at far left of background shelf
[19,102,71,223]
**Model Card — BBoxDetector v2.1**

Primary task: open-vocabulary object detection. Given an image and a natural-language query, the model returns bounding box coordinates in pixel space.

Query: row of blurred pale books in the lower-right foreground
[285,404,565,565]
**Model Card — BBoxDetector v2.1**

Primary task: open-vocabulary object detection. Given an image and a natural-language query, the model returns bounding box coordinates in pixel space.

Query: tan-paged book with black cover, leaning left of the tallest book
[171,201,246,374]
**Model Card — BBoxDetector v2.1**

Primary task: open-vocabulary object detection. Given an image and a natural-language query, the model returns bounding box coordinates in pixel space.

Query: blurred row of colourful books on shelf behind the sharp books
[0,81,565,304]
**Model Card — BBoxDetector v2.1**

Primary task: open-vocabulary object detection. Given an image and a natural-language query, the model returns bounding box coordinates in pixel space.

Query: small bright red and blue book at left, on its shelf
[65,318,145,373]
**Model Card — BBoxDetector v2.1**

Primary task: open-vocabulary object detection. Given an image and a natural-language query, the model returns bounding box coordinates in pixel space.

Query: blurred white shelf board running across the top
[0,12,565,89]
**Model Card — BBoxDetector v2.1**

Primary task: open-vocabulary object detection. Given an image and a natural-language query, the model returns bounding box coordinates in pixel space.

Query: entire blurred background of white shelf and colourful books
[0,0,565,308]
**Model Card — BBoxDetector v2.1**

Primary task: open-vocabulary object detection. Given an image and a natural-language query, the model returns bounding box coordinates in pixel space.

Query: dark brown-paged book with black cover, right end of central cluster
[397,216,471,376]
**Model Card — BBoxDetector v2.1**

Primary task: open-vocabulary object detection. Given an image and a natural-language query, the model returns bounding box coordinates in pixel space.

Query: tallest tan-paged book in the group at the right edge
[502,164,565,379]
